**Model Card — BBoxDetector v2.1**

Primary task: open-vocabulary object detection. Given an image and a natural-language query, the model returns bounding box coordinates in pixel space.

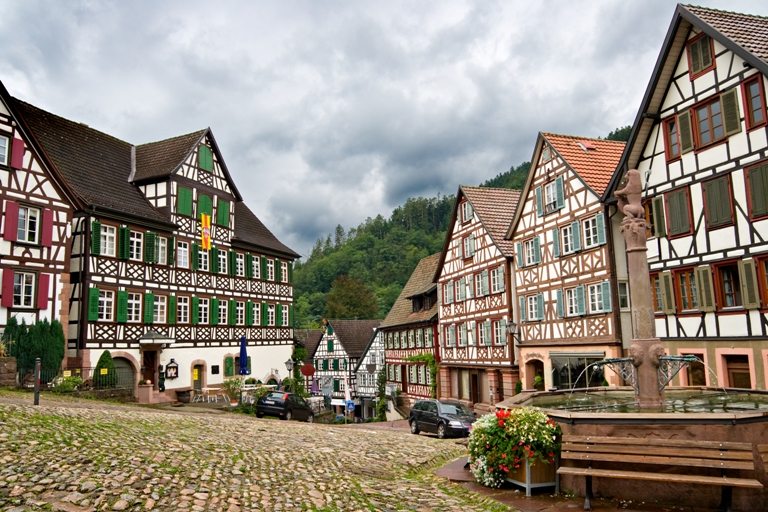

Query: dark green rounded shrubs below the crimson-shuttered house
[2,317,65,375]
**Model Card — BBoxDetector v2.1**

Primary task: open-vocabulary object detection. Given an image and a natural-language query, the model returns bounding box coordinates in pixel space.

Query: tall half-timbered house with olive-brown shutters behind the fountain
[605,5,768,389]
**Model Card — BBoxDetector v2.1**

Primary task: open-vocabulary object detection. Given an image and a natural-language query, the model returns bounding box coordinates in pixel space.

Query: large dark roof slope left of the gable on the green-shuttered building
[12,98,169,223]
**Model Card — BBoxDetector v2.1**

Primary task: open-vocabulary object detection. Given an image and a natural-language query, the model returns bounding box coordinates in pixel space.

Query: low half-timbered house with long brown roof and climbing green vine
[380,253,440,407]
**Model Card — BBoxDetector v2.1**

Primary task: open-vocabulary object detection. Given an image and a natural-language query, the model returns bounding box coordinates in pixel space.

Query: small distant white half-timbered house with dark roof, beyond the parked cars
[311,320,380,417]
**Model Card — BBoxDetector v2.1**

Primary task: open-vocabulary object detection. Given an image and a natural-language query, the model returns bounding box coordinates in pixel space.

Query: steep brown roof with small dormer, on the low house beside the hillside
[379,253,440,328]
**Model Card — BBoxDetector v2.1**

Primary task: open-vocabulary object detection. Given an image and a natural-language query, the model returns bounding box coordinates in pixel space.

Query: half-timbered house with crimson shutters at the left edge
[0,82,74,352]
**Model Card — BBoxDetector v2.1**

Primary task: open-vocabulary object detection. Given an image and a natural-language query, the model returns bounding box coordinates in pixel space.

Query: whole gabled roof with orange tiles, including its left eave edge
[506,132,625,237]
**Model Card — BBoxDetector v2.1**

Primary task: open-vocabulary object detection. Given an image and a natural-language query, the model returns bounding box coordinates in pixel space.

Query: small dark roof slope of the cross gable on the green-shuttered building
[133,130,208,182]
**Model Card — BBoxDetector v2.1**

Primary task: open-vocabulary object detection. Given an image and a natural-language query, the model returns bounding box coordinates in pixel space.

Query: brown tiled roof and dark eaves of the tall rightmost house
[603,4,768,202]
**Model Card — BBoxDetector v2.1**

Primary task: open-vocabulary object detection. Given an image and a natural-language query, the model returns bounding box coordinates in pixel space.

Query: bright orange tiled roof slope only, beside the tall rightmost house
[542,133,626,195]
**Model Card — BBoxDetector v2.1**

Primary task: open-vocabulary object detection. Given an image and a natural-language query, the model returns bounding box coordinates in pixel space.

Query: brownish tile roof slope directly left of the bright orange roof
[461,186,520,257]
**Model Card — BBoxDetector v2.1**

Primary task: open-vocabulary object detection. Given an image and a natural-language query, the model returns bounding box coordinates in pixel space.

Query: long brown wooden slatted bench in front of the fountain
[557,435,763,511]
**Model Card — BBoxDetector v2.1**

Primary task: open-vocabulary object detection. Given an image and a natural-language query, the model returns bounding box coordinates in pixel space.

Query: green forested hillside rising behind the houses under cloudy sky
[294,126,629,327]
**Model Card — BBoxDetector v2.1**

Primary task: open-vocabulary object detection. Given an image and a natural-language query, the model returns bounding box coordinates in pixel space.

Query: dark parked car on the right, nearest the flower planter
[408,400,476,439]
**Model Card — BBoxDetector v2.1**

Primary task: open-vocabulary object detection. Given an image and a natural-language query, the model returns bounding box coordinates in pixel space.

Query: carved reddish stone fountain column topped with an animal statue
[615,169,664,409]
